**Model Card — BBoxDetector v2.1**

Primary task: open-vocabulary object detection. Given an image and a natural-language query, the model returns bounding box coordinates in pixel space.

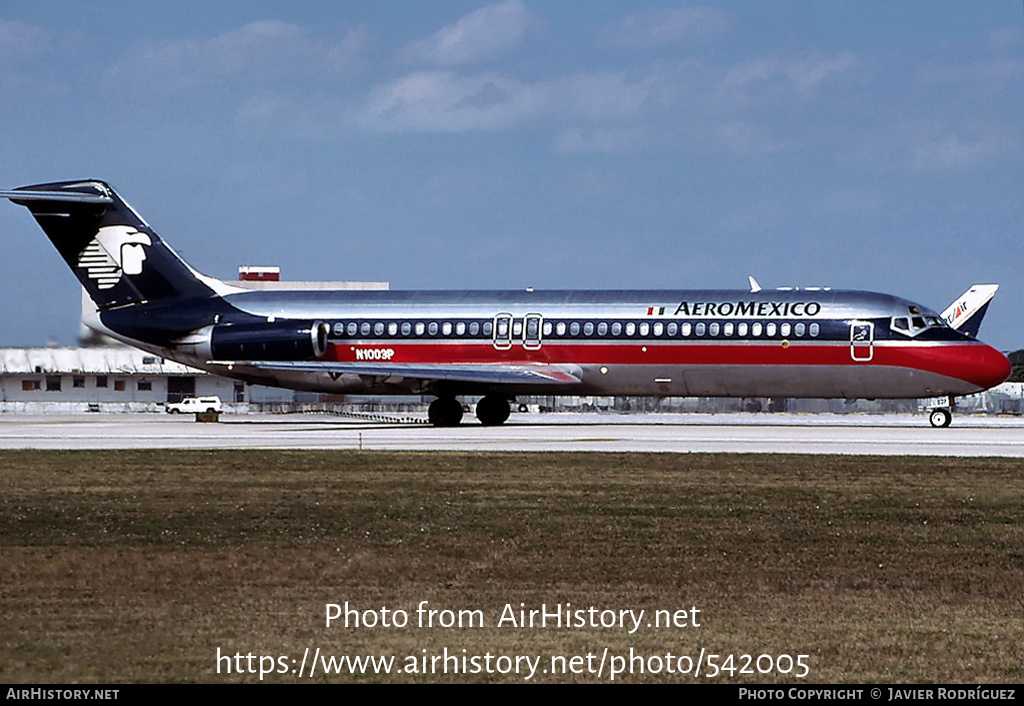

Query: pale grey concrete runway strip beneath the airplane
[0,414,1024,457]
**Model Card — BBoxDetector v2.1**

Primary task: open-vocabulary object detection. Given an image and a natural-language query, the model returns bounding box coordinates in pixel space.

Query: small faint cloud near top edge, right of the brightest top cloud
[601,7,729,48]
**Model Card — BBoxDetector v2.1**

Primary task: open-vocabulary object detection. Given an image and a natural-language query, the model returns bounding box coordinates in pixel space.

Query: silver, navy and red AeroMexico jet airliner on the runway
[0,179,1010,427]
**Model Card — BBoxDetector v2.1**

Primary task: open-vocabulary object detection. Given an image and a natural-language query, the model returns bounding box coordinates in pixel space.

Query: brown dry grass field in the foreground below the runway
[0,451,1024,683]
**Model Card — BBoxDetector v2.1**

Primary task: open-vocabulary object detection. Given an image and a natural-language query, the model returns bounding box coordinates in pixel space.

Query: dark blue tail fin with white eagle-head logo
[0,180,216,309]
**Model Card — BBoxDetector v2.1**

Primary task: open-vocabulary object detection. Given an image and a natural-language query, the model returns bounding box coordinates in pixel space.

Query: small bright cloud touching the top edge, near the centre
[403,0,532,66]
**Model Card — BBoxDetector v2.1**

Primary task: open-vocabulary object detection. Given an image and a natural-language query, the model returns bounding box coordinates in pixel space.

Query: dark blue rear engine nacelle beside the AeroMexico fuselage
[209,320,331,361]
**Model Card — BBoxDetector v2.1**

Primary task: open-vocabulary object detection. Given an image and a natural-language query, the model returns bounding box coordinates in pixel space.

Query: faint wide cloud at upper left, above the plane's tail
[108,19,367,88]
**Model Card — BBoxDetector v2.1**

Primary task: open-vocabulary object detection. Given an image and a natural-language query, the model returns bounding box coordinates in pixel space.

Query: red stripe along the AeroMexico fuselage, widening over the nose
[324,340,1010,388]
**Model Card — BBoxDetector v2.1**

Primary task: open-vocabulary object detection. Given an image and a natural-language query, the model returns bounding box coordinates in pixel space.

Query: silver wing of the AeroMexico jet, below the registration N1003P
[210,361,583,385]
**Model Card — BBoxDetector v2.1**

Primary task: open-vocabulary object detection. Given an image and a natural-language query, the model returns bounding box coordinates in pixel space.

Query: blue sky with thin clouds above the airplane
[0,0,1024,350]
